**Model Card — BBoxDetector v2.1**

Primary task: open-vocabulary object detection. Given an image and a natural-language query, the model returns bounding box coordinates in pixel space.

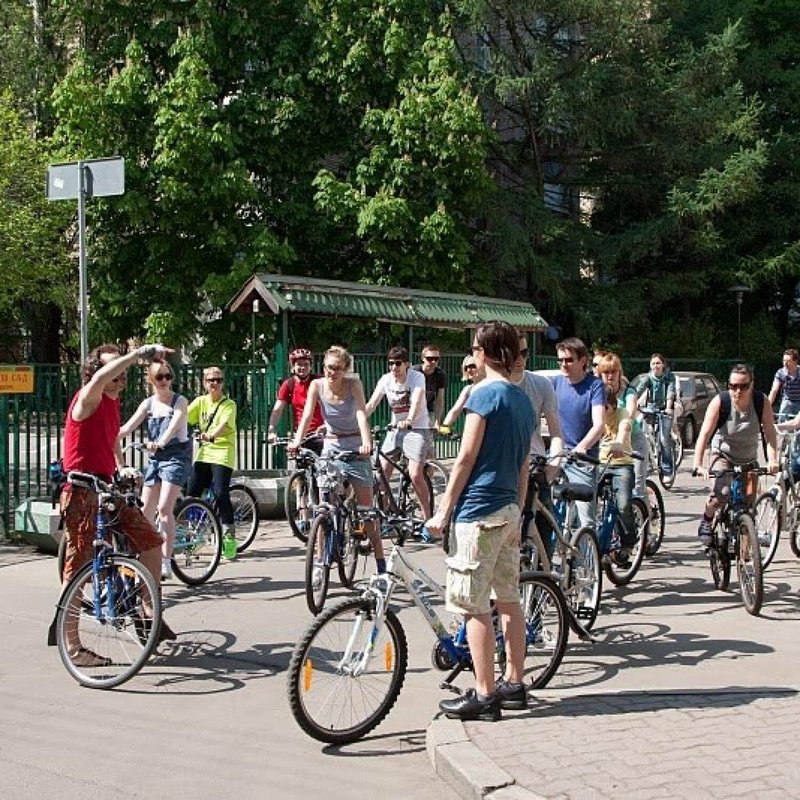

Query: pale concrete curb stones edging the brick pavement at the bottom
[425,717,542,800]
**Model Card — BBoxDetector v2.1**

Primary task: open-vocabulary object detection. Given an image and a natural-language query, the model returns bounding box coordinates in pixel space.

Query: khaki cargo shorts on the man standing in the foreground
[445,504,519,615]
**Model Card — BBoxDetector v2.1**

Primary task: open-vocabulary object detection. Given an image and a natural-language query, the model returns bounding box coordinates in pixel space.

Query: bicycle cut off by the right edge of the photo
[753,433,800,569]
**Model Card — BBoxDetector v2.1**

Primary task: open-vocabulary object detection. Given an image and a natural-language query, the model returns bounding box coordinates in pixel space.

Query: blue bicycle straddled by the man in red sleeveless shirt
[55,471,161,689]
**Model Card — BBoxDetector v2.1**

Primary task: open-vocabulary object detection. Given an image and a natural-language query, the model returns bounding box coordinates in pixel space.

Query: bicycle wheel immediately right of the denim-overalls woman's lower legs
[172,497,222,586]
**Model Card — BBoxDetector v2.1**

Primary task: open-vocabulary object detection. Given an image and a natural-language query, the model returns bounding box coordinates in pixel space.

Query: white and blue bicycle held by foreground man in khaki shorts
[287,511,571,744]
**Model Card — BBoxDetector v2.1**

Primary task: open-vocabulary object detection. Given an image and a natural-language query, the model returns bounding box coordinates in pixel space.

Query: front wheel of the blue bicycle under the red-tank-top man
[56,554,161,689]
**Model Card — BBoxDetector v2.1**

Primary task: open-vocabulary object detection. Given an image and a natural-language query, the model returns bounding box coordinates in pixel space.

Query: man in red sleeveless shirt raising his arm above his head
[60,344,175,666]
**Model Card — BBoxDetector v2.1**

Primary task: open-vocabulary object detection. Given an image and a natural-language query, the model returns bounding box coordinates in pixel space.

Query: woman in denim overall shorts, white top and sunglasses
[118,360,192,579]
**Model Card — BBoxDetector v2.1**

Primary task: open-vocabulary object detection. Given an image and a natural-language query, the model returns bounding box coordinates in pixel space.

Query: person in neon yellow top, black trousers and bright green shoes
[187,367,236,537]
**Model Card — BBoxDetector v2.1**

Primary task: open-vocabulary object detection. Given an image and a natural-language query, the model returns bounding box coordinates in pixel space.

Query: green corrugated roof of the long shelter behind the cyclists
[228,274,547,331]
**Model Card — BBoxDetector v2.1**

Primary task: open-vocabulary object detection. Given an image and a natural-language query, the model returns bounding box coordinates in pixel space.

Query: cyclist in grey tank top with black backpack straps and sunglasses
[692,364,778,545]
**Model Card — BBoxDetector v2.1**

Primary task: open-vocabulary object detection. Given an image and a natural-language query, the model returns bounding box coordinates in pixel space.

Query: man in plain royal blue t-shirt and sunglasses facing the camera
[552,337,606,526]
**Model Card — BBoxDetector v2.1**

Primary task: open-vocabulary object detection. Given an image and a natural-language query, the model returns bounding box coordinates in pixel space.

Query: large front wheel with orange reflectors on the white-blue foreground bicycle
[287,597,408,744]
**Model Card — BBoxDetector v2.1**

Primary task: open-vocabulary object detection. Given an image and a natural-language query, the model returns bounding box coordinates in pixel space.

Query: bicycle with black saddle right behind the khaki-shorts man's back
[520,451,603,631]
